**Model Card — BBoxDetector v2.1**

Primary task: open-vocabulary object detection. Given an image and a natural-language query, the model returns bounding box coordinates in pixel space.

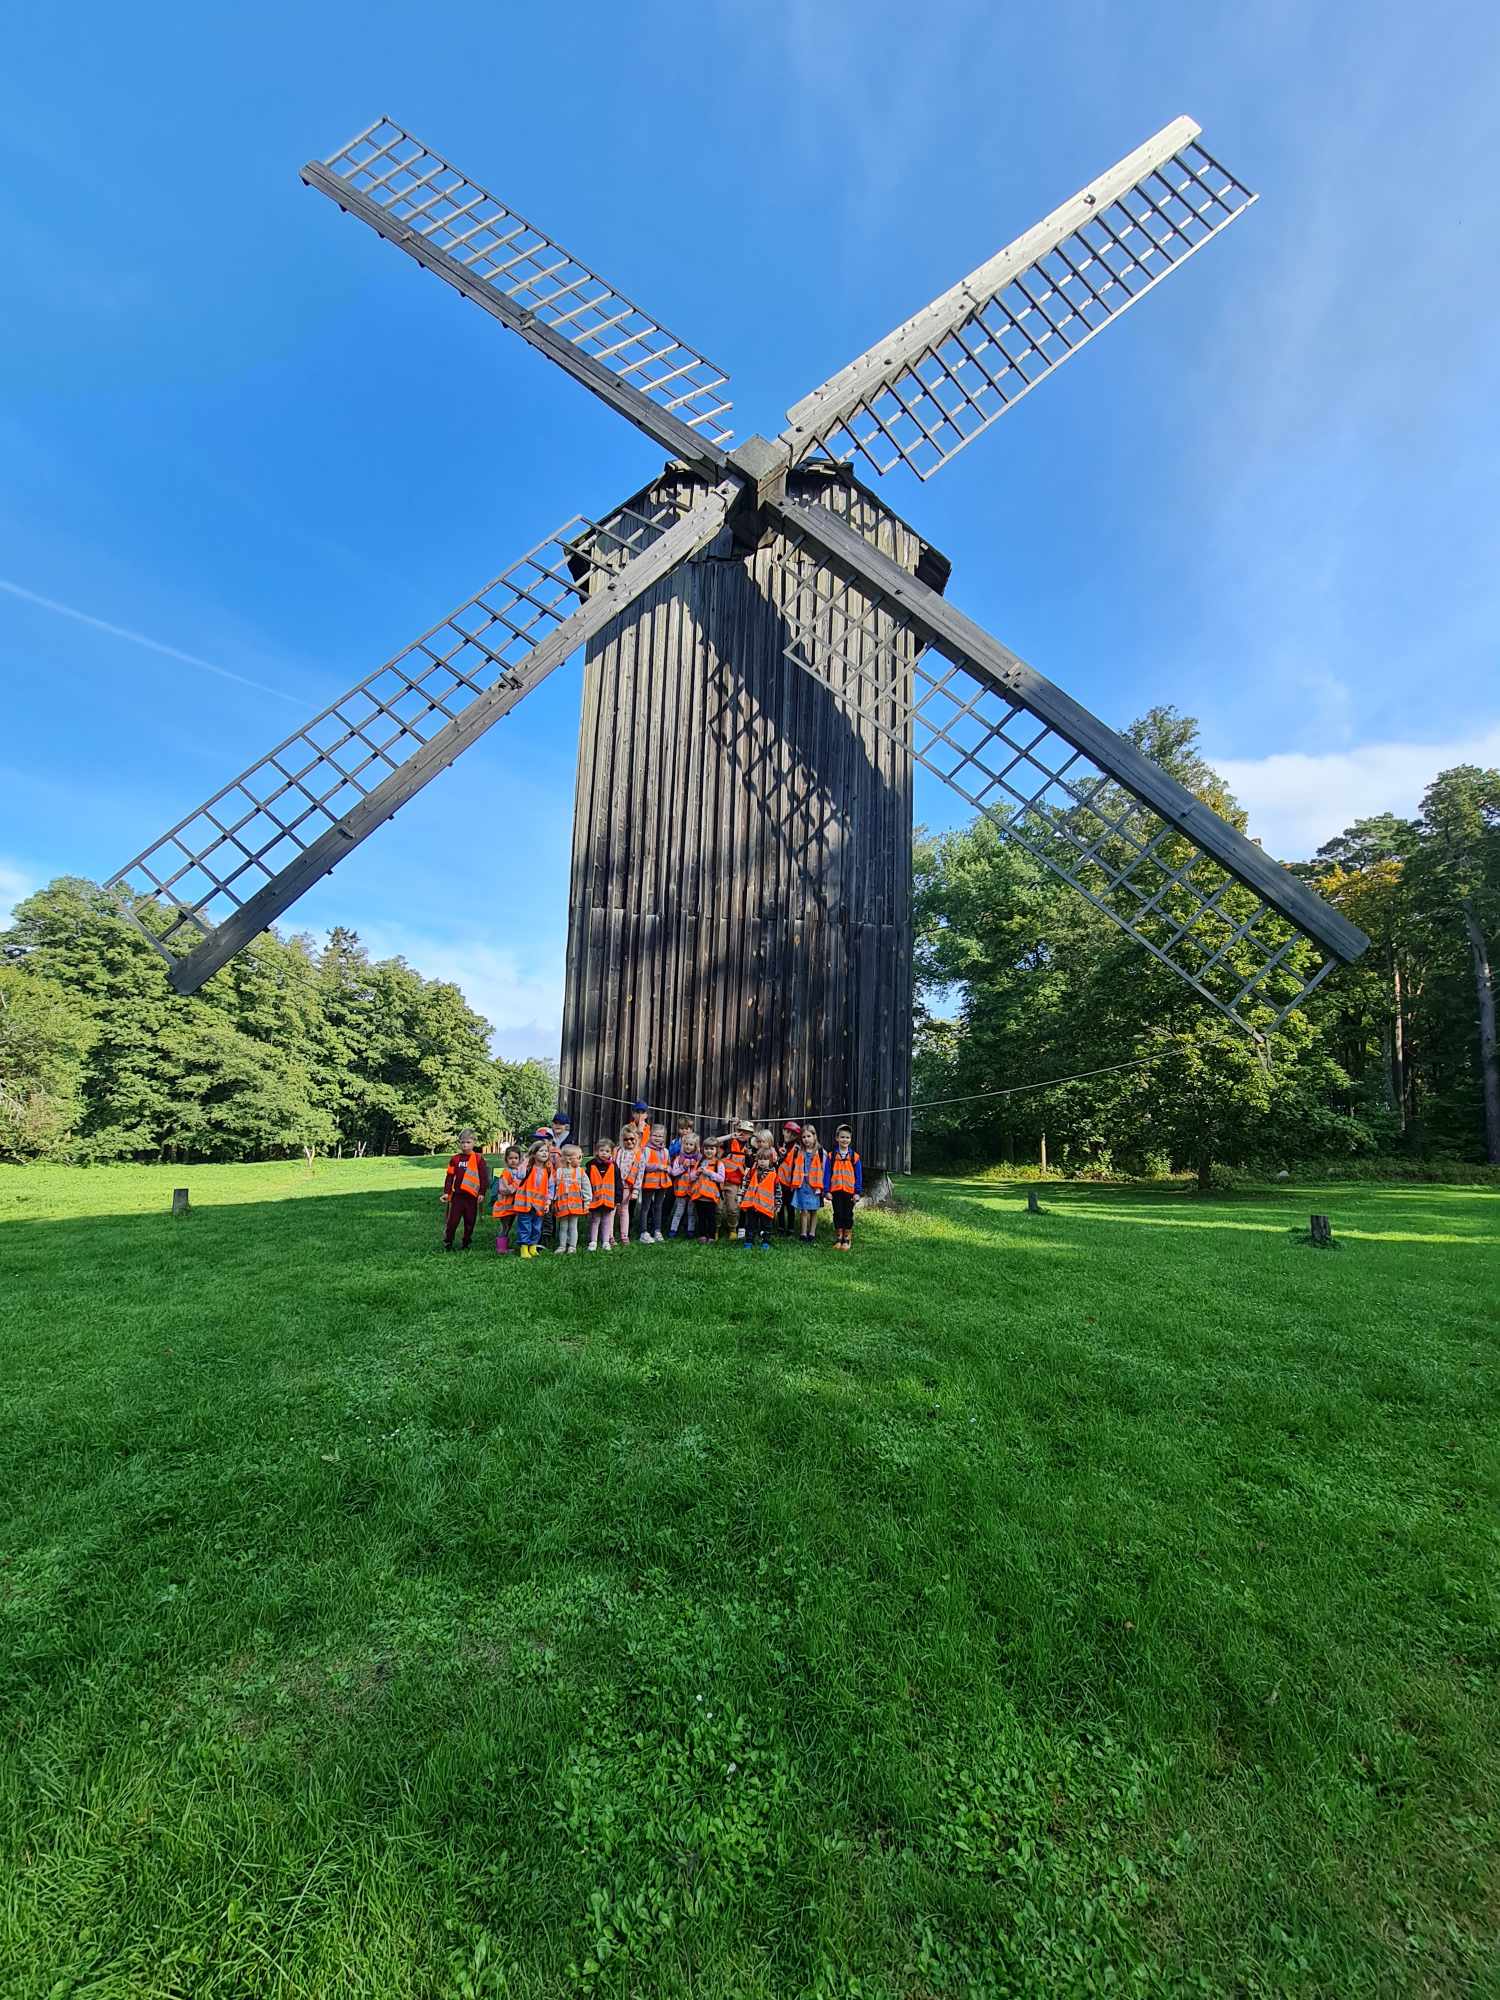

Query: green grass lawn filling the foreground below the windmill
[0,1160,1500,2000]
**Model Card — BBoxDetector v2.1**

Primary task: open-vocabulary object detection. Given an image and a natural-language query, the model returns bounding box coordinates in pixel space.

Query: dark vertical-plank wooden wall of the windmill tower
[560,468,948,1172]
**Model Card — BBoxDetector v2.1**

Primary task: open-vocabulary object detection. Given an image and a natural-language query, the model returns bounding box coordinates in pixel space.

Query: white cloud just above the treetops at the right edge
[1210,724,1500,860]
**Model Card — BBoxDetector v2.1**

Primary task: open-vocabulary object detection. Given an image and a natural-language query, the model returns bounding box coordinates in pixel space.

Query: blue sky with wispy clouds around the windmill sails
[0,0,1500,1054]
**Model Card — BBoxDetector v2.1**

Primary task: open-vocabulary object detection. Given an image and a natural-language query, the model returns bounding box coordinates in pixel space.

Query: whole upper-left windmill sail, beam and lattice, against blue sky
[302,118,732,464]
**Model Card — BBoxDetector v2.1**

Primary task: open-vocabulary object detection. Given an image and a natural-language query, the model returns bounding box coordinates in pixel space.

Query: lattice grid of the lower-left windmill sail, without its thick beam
[110,496,692,960]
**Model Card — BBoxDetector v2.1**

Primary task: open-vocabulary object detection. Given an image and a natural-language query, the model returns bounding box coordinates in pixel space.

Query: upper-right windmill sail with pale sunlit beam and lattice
[782,118,1256,480]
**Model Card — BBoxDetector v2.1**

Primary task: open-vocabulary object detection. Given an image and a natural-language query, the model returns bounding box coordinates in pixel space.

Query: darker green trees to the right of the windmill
[914,708,1500,1186]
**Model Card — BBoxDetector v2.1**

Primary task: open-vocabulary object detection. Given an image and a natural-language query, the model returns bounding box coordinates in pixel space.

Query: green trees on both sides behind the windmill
[0,708,1500,1186]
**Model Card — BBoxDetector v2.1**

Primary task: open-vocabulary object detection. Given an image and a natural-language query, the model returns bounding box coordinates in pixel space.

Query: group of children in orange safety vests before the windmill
[442,1102,864,1258]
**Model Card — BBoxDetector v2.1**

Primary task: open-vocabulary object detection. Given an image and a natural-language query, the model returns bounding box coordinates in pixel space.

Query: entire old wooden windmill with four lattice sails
[114,118,1368,1168]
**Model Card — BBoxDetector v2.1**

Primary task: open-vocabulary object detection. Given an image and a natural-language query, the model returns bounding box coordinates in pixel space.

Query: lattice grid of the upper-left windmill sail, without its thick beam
[322,118,732,444]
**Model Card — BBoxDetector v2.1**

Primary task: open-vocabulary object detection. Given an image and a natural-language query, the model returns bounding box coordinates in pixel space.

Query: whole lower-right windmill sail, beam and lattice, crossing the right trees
[780,500,1368,1034]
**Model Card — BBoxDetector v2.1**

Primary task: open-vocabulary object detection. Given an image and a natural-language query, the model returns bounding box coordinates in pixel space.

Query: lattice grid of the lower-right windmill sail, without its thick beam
[776,534,1338,1040]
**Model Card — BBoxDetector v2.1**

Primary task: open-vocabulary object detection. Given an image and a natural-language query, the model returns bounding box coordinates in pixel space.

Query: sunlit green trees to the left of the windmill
[0,878,558,1162]
